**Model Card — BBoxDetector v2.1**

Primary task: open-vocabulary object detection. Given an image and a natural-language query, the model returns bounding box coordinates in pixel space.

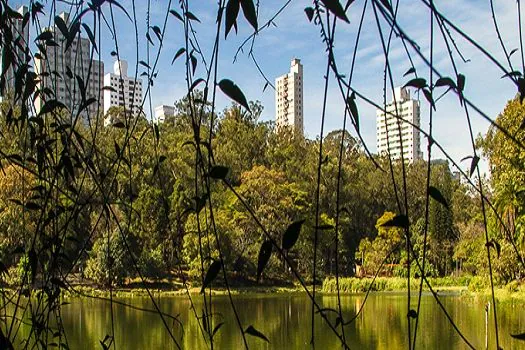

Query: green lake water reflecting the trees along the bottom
[10,293,525,350]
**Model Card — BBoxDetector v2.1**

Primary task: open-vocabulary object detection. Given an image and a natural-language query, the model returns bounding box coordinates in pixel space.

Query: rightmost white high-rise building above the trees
[376,87,423,162]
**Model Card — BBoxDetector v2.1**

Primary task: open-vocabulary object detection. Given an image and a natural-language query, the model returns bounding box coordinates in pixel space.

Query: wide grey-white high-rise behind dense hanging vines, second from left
[35,12,104,122]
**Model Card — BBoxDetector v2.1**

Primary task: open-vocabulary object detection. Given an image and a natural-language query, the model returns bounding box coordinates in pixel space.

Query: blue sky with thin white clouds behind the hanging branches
[25,0,522,174]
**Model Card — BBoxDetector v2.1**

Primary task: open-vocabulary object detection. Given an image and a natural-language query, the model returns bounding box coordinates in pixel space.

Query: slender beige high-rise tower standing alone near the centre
[275,58,303,136]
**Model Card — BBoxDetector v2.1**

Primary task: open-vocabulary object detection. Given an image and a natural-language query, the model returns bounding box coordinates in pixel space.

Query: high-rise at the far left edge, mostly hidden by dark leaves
[0,6,29,101]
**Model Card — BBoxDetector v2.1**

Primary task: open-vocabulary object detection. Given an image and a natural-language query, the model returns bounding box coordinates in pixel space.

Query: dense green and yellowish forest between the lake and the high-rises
[0,93,524,287]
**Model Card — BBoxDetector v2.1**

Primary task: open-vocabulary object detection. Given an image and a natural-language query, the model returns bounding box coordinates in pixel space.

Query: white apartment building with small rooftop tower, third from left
[104,60,142,125]
